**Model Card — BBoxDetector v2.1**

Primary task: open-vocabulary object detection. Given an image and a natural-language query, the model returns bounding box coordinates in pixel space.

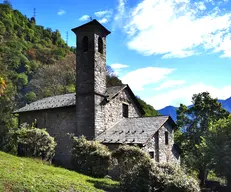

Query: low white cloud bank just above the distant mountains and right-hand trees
[144,83,231,109]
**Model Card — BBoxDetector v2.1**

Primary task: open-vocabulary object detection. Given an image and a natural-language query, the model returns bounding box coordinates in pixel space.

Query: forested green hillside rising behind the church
[0,1,159,148]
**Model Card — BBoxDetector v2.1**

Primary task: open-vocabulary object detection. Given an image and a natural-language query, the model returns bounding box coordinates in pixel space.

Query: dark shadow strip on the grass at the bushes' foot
[87,179,120,192]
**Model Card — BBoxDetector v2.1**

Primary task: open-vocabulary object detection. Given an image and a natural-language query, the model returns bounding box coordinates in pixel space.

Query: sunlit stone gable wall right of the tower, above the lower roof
[105,89,141,129]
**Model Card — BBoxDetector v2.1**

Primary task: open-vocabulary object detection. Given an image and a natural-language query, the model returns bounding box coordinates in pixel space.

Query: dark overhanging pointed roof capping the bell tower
[72,19,111,36]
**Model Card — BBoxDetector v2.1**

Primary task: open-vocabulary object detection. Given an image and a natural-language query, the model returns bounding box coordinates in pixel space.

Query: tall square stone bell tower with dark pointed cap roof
[72,19,111,139]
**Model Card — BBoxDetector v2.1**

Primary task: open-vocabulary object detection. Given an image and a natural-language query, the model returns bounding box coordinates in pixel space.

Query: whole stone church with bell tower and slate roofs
[14,20,180,167]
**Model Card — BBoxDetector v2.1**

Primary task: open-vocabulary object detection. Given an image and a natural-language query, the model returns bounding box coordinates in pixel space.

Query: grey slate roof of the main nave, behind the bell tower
[13,85,143,114]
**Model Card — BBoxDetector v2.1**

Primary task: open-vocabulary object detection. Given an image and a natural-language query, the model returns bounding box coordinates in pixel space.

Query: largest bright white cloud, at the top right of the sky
[122,0,231,58]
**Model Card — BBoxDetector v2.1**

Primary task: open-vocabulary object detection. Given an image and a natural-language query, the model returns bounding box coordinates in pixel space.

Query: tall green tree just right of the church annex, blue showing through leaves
[176,92,229,185]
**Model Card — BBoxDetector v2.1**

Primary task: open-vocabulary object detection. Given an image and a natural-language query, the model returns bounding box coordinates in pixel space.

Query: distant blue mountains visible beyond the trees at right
[158,97,231,121]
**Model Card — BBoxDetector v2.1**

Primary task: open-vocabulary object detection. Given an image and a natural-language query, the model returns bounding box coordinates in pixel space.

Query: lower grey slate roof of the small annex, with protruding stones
[96,116,172,144]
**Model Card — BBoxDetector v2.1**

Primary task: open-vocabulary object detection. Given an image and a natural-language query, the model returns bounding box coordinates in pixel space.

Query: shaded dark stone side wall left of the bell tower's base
[19,106,76,168]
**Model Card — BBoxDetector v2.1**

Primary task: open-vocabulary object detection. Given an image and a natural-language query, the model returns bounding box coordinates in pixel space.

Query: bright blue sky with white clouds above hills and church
[4,0,231,109]
